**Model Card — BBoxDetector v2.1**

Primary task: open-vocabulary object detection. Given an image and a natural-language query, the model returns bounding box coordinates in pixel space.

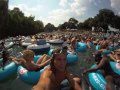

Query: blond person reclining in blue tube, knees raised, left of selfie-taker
[10,50,50,71]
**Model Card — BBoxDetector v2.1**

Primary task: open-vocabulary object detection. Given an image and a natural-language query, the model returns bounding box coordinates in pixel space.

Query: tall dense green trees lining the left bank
[0,3,44,38]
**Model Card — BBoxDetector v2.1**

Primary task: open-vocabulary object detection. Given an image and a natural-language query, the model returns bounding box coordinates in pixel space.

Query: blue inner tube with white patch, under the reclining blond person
[18,56,44,84]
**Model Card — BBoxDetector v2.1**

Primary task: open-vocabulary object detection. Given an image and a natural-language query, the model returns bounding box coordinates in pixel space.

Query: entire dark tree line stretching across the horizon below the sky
[0,0,120,38]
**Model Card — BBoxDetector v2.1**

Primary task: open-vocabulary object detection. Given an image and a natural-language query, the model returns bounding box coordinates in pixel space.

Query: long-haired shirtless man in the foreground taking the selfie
[33,50,82,90]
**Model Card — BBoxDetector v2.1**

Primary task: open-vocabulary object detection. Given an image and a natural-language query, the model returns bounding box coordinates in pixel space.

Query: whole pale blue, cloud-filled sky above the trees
[9,0,120,26]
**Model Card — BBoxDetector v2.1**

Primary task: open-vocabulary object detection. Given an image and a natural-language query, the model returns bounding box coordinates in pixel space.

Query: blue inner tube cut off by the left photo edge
[0,59,18,81]
